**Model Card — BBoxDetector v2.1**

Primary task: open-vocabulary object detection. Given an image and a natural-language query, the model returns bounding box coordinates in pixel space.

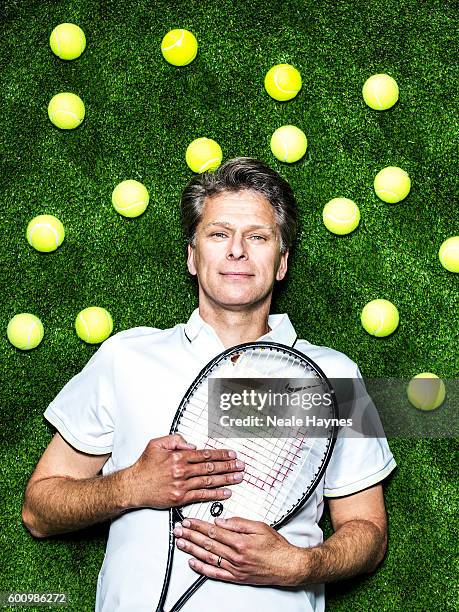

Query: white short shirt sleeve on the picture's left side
[44,337,116,455]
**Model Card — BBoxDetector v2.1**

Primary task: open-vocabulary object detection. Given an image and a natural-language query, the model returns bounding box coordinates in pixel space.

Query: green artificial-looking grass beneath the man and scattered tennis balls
[0,0,459,611]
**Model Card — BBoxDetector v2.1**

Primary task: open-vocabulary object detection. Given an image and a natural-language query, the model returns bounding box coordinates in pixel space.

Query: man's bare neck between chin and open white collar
[199,304,271,348]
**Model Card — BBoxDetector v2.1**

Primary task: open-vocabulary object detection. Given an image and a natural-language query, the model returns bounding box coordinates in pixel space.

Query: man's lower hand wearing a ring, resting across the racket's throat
[174,517,298,586]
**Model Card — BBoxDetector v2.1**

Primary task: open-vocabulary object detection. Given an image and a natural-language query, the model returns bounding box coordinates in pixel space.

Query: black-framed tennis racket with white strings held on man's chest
[156,342,338,612]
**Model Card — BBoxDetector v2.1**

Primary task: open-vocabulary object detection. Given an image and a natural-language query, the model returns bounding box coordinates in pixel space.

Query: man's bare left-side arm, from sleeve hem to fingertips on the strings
[22,433,244,538]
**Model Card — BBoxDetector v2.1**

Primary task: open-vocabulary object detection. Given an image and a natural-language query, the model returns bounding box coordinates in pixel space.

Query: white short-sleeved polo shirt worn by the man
[45,309,395,612]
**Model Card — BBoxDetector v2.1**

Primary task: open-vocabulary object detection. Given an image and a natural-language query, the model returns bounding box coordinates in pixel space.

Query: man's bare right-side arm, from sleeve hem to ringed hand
[174,484,387,586]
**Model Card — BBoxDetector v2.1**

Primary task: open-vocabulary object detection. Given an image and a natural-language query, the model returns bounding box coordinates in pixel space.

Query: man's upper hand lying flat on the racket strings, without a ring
[128,434,244,508]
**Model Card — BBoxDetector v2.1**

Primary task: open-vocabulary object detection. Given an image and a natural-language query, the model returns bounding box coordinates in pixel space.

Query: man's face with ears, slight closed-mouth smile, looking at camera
[188,191,288,310]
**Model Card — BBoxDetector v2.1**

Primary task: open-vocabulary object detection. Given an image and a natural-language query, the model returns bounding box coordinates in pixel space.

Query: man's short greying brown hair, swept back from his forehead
[181,157,298,253]
